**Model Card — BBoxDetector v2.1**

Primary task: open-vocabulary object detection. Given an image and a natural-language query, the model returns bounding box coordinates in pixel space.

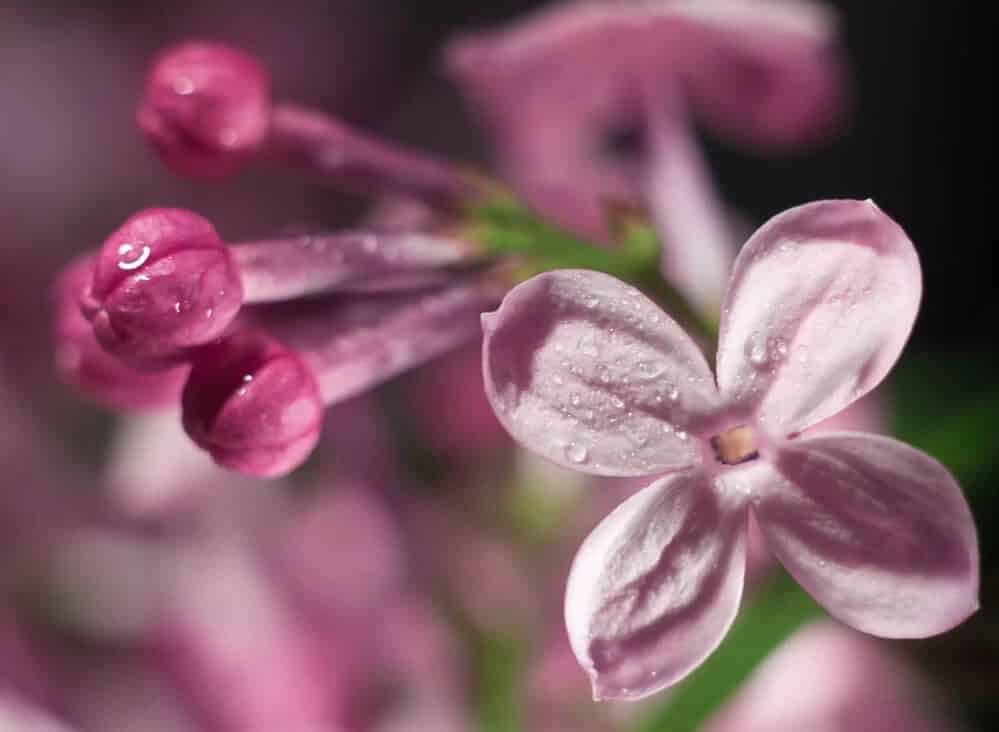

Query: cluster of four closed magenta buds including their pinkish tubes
[57,43,502,476]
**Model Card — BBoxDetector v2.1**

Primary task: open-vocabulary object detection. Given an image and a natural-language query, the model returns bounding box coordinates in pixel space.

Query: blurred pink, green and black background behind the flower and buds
[0,0,999,732]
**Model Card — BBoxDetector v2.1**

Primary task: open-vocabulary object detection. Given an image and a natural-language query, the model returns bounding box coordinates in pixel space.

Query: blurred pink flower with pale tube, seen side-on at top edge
[447,0,843,307]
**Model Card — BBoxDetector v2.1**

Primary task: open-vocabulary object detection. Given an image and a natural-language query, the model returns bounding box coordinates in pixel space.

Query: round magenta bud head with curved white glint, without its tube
[80,208,243,368]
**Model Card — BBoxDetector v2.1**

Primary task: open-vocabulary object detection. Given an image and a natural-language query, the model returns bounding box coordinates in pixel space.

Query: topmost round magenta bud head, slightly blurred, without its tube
[136,42,271,178]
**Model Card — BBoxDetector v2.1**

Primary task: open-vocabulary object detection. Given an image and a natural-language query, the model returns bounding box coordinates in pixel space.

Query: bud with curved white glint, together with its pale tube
[76,208,472,368]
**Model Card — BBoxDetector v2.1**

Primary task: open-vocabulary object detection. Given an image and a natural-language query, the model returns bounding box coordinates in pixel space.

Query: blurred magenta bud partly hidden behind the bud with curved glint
[54,257,187,410]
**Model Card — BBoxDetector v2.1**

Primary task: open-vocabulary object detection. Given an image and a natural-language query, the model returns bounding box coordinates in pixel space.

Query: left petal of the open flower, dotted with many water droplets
[483,270,716,476]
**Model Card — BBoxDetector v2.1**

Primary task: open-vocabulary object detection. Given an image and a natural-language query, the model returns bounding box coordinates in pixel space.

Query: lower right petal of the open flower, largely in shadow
[754,432,978,638]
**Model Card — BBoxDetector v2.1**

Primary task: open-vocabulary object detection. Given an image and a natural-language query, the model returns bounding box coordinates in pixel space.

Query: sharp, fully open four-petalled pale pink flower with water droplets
[483,201,978,698]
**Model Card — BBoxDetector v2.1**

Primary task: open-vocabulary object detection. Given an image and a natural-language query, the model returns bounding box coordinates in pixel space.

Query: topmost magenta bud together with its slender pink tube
[137,43,475,203]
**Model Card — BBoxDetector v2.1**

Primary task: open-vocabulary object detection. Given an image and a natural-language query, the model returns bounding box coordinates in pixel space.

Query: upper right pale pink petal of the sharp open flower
[718,200,922,435]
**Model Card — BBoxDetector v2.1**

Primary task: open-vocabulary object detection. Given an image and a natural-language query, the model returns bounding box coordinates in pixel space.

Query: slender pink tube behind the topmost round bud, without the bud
[266,104,475,206]
